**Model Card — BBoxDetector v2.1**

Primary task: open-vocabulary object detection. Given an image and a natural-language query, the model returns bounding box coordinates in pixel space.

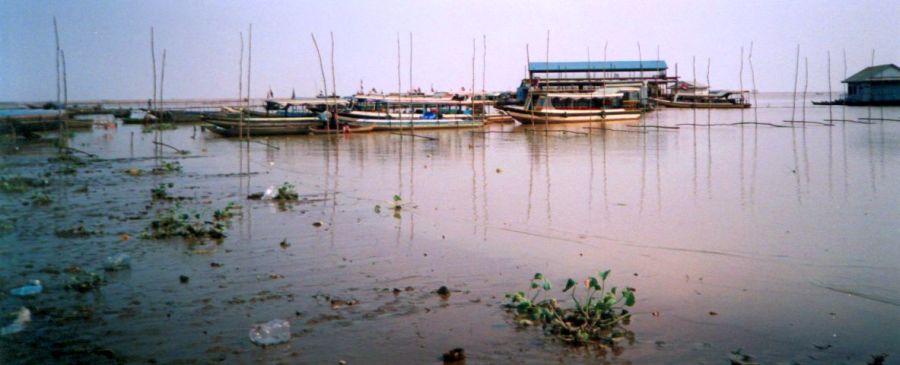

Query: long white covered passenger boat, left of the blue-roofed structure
[338,94,486,131]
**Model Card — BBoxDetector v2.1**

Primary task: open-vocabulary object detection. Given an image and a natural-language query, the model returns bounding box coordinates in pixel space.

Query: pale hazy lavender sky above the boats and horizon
[0,0,900,101]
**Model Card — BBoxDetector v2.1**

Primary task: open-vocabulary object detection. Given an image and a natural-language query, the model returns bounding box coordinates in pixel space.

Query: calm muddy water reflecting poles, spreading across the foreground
[0,95,900,363]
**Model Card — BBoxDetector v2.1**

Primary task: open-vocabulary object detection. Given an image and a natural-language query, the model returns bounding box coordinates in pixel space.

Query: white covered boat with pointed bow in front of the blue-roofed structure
[497,88,641,125]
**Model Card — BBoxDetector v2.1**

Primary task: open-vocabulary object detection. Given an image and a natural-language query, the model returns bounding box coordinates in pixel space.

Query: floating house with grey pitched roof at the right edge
[842,64,900,105]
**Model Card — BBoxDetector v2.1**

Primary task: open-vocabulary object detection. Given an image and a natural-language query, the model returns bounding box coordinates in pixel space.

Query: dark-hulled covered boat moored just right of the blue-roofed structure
[652,81,750,109]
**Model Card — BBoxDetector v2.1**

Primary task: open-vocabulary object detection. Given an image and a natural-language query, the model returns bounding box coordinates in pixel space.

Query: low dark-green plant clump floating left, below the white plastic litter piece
[142,207,234,241]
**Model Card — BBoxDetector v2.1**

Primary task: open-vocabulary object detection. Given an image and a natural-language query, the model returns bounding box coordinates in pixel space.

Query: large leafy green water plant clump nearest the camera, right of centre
[504,270,635,345]
